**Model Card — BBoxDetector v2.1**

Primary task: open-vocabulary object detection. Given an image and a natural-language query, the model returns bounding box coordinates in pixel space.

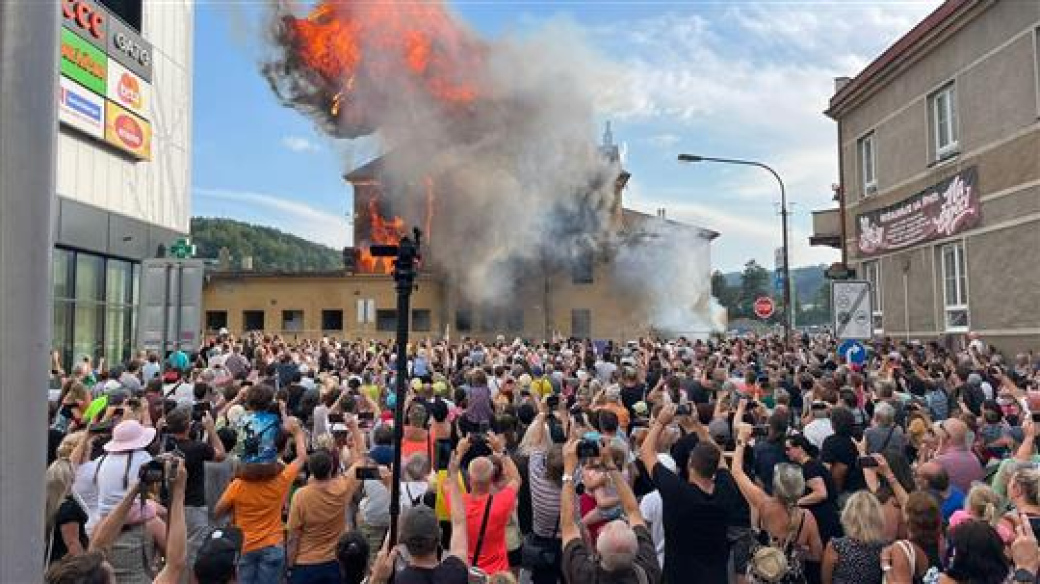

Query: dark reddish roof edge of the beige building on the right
[825,0,985,118]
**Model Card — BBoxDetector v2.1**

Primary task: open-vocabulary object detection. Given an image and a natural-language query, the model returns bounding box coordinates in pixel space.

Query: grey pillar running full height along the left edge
[0,0,60,582]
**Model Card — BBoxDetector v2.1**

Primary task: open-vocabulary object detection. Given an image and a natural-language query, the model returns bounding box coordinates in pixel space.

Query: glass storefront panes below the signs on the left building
[51,247,140,368]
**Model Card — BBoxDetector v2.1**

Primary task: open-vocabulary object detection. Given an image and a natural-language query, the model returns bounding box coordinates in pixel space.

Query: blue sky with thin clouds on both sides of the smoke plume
[191,0,940,271]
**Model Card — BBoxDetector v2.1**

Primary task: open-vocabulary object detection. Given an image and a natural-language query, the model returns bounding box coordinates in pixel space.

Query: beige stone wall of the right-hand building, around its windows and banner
[832,1,1040,351]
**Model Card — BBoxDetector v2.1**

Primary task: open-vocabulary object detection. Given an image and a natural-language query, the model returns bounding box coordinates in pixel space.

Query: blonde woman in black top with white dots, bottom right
[821,490,886,584]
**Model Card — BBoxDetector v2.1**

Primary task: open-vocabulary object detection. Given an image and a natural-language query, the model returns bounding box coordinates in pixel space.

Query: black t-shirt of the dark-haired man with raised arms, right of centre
[651,464,729,584]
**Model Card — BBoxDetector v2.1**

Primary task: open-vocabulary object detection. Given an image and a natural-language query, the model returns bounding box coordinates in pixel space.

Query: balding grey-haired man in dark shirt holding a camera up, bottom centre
[560,432,660,584]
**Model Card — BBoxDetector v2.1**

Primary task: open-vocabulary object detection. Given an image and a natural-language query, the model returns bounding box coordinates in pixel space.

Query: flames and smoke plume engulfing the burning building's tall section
[200,0,717,338]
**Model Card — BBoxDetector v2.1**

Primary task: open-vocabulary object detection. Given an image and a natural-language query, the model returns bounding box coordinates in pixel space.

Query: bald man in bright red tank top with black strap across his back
[459,433,520,574]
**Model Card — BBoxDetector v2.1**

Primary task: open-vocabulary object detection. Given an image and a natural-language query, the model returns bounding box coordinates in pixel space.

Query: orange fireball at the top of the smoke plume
[282,0,484,135]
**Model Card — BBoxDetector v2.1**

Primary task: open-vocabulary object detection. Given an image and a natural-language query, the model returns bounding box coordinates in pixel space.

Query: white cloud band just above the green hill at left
[194,187,354,249]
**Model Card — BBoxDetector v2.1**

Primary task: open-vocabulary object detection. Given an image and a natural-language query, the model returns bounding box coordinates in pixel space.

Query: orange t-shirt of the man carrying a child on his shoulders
[220,464,300,554]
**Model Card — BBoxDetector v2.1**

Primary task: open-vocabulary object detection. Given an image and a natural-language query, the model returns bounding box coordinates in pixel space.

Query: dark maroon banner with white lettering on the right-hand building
[856,166,982,256]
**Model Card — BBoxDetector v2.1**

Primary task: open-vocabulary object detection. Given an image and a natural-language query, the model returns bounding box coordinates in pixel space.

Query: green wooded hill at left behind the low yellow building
[191,217,343,271]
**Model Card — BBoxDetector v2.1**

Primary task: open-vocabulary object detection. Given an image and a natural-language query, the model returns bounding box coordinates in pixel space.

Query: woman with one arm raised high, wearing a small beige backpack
[730,400,823,582]
